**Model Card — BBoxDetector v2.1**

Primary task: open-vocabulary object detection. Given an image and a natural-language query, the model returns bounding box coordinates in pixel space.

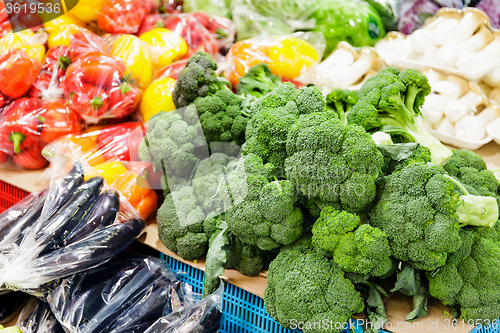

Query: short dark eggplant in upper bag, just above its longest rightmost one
[64,190,120,246]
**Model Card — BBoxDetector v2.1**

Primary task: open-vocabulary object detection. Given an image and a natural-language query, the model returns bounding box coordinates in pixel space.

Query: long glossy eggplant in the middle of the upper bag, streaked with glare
[35,177,104,256]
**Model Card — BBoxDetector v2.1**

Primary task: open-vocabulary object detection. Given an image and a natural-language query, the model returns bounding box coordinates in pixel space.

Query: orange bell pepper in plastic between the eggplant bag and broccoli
[94,161,158,219]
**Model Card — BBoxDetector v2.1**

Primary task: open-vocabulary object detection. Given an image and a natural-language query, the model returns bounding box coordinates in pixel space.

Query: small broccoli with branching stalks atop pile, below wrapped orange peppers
[236,62,281,98]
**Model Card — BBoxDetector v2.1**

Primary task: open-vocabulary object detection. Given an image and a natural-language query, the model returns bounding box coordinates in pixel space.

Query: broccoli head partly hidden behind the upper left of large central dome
[241,83,325,168]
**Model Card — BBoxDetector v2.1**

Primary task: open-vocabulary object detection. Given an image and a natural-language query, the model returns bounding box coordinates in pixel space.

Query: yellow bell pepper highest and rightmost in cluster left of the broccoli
[139,28,188,70]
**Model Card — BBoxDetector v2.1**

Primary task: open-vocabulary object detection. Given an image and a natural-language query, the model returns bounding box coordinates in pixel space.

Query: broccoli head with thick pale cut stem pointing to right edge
[370,162,498,271]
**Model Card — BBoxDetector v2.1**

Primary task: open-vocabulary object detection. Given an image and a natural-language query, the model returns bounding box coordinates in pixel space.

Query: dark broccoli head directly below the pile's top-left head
[193,90,248,155]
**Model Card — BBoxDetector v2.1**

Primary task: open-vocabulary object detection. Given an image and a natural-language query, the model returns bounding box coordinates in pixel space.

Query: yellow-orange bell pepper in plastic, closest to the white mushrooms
[267,37,319,79]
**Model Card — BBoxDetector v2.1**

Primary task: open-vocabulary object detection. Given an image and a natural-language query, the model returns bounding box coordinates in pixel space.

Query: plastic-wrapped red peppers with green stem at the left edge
[0,97,82,169]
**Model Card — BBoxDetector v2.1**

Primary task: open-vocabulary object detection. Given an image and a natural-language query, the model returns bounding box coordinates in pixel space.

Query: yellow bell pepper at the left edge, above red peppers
[0,30,45,64]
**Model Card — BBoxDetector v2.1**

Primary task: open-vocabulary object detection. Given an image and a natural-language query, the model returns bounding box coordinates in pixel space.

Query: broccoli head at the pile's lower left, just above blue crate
[156,187,208,260]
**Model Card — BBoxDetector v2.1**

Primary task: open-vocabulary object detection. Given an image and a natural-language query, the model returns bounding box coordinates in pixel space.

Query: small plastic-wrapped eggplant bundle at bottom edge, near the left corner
[16,298,64,333]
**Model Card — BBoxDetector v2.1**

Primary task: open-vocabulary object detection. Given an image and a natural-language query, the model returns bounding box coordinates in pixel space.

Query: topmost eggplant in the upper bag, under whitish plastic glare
[46,161,85,220]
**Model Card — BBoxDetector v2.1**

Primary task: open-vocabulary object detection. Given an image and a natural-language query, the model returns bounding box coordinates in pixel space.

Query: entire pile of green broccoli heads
[151,59,500,326]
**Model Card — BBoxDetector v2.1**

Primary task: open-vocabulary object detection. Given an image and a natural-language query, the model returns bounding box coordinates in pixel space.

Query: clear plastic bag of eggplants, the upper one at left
[0,152,145,298]
